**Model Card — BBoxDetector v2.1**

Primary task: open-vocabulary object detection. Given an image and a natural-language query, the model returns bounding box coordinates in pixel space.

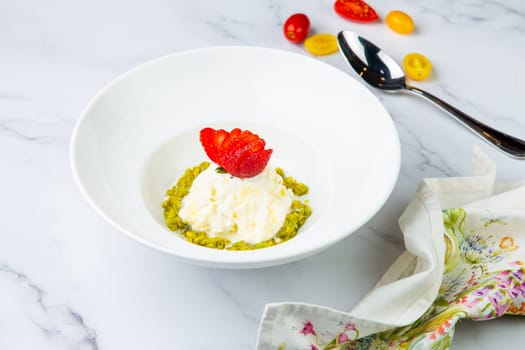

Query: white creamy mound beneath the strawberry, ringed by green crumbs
[179,165,294,243]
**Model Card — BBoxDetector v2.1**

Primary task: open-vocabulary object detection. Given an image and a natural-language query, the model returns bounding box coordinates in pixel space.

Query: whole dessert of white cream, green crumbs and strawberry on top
[162,128,311,250]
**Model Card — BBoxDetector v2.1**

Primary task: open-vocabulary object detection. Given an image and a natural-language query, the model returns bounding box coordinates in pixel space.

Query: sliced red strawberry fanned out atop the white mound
[200,128,272,178]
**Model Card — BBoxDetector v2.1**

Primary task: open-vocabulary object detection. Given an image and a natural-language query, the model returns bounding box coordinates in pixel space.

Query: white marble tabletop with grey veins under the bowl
[0,0,525,349]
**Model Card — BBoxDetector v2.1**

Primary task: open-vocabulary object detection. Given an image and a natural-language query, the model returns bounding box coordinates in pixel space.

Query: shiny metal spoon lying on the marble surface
[337,30,525,159]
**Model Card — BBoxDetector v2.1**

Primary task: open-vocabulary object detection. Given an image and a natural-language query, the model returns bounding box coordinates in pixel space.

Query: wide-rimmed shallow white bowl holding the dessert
[71,47,400,268]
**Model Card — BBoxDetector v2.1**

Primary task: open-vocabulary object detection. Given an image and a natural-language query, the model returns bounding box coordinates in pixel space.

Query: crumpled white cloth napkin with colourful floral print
[257,149,525,350]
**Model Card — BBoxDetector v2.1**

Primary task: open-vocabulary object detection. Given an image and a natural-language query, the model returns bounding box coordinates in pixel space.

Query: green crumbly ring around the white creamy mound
[162,162,312,250]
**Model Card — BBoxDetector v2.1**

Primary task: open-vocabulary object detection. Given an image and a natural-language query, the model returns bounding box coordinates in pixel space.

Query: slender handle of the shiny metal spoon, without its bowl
[406,85,525,159]
